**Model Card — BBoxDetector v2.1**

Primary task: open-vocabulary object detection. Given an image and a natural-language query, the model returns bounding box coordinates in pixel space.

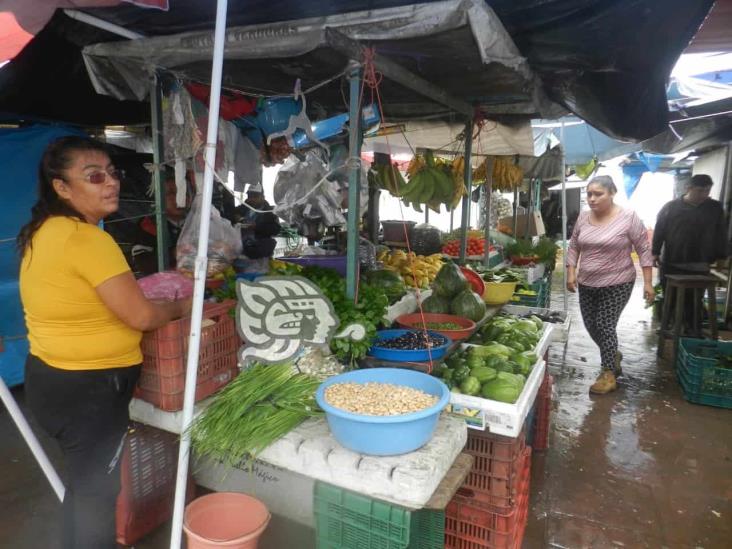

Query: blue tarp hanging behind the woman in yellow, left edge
[0,126,84,387]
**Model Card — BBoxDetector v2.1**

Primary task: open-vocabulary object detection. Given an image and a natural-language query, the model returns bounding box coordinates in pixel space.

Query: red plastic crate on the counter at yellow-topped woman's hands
[135,301,241,412]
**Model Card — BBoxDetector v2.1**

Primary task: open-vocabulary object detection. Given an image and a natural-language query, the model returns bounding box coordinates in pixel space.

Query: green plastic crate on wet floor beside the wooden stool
[676,338,732,409]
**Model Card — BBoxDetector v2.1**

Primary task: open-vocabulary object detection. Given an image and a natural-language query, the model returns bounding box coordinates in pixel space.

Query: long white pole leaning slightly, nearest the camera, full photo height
[170,0,228,549]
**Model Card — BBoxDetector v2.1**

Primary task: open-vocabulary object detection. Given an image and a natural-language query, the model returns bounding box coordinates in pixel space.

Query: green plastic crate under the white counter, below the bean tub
[314,482,445,549]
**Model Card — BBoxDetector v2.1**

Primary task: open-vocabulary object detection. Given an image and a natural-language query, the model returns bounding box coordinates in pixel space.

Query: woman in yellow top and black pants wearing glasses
[18,137,190,549]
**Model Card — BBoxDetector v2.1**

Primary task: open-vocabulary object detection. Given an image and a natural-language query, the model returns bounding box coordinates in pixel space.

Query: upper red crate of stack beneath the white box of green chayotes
[457,429,527,511]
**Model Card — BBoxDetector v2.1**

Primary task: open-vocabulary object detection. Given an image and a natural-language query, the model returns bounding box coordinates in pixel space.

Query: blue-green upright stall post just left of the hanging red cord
[346,63,362,299]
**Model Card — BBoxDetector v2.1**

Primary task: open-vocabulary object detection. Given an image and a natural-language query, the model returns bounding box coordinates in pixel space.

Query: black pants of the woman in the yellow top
[25,355,140,549]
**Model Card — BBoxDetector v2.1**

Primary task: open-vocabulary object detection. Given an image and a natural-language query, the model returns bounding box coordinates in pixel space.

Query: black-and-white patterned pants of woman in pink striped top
[579,282,634,369]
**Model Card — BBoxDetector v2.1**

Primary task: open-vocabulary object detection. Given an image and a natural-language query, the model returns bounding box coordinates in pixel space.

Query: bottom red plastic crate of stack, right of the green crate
[445,448,531,549]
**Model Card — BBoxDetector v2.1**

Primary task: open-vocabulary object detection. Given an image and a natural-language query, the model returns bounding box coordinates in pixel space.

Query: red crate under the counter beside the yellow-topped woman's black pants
[116,424,195,545]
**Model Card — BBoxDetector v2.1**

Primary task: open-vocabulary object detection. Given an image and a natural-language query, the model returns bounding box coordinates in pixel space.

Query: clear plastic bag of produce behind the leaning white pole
[176,194,242,278]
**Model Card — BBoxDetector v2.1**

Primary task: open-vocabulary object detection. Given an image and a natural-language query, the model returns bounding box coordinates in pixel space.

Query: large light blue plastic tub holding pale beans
[315,368,450,456]
